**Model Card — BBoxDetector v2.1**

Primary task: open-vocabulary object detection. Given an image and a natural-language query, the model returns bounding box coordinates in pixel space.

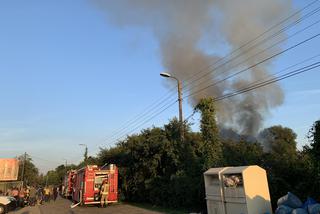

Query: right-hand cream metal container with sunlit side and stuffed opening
[222,166,272,214]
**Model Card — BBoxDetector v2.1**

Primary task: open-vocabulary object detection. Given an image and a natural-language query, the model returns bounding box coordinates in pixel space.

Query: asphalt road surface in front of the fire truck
[9,198,159,214]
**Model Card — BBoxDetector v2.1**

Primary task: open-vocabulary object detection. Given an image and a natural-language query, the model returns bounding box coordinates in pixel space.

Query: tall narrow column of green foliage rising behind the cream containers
[195,98,222,170]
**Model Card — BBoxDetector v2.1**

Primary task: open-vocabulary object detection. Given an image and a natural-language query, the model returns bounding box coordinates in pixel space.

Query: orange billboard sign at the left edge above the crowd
[0,158,19,181]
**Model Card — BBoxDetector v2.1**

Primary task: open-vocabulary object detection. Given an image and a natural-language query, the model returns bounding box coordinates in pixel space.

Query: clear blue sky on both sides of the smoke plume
[0,0,320,171]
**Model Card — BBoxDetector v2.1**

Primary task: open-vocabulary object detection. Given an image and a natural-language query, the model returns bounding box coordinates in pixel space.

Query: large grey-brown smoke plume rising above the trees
[91,0,292,136]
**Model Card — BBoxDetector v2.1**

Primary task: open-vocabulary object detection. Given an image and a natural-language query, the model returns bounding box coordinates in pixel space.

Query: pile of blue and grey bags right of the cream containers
[275,192,320,214]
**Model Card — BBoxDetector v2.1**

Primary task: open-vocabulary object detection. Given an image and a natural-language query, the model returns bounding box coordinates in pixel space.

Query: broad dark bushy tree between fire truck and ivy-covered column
[98,118,204,210]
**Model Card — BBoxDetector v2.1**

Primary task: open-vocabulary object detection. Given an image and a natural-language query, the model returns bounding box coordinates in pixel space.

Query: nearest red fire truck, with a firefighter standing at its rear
[72,164,118,205]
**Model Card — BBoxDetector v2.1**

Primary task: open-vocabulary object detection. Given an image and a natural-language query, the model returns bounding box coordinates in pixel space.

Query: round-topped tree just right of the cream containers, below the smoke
[260,125,307,207]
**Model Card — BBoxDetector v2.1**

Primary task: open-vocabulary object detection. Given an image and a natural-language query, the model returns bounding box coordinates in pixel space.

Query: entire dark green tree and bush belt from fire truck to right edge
[93,99,320,211]
